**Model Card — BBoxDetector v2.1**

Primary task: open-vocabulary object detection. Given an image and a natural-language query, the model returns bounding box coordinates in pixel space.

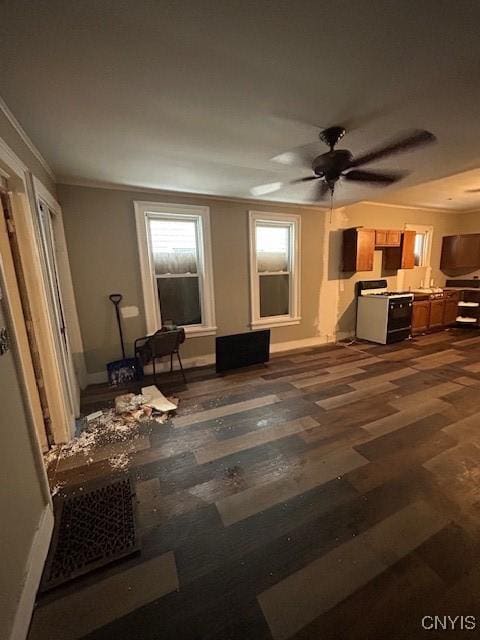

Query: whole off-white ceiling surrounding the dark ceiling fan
[0,0,480,209]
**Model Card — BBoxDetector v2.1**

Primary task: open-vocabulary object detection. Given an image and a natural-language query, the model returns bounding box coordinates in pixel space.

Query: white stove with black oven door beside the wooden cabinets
[356,280,413,344]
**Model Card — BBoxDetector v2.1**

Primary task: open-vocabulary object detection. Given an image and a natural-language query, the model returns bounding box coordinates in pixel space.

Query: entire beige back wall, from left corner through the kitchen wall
[57,185,464,374]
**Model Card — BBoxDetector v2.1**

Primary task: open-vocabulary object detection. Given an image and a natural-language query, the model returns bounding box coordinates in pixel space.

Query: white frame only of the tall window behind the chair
[134,201,217,337]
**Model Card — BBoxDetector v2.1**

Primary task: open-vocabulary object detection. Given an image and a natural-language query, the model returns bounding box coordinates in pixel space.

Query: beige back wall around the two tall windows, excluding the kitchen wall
[57,185,325,373]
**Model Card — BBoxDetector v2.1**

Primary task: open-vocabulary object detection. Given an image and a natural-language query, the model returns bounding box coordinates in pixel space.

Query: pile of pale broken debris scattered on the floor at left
[45,385,179,476]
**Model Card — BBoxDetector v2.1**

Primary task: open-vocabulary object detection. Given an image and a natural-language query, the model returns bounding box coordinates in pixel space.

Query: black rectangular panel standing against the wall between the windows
[215,329,270,373]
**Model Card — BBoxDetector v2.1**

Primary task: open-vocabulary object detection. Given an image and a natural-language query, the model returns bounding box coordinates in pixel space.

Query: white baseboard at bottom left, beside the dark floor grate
[9,504,53,640]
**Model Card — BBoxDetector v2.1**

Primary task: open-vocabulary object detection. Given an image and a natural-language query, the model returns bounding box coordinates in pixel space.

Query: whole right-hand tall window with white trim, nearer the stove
[250,211,301,327]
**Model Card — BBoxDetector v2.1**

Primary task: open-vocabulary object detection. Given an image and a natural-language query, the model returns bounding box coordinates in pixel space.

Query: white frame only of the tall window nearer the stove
[249,211,302,329]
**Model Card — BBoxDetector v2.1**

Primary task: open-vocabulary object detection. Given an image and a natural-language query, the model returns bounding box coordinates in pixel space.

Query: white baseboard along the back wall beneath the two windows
[87,333,351,385]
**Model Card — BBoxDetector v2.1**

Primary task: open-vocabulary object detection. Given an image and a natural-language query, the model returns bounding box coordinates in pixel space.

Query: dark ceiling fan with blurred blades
[251,126,436,200]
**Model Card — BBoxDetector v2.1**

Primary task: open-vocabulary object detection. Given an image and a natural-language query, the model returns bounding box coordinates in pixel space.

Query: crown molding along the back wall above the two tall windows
[57,177,330,213]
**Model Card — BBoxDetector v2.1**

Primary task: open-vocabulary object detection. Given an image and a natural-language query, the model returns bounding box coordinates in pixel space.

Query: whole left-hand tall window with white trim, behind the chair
[135,202,216,335]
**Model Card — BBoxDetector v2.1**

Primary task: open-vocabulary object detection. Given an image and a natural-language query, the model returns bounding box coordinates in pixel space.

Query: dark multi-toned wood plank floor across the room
[29,329,480,640]
